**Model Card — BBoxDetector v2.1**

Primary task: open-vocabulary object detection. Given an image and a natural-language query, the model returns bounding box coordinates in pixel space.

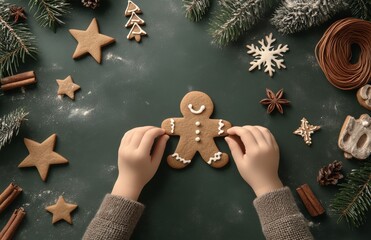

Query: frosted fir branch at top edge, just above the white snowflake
[271,0,352,34]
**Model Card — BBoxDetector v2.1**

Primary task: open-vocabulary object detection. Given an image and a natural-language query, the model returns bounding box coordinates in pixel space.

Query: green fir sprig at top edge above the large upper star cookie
[28,0,70,31]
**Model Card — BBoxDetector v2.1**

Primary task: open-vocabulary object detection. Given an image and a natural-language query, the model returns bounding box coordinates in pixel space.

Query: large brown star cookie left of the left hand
[18,134,68,182]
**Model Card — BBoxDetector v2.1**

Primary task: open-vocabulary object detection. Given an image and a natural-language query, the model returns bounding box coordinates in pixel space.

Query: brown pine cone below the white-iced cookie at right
[317,160,344,186]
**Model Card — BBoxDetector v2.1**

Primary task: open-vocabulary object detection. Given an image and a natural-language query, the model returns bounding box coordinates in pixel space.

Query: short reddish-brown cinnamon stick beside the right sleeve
[296,184,325,217]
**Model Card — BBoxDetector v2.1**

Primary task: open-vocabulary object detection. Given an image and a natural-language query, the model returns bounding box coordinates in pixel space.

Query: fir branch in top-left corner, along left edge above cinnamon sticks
[0,1,37,77]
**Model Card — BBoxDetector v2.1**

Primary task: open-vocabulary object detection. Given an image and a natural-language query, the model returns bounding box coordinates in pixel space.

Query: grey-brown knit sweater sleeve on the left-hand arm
[83,194,144,240]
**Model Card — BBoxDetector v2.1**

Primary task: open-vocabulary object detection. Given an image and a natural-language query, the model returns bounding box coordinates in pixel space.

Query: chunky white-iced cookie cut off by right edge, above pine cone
[338,114,371,160]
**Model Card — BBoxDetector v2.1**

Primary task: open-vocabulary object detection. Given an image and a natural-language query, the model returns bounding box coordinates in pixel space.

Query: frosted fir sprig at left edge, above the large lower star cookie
[0,108,28,149]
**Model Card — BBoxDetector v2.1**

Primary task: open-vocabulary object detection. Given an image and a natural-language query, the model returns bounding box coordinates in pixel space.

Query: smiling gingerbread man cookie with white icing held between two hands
[161,91,231,169]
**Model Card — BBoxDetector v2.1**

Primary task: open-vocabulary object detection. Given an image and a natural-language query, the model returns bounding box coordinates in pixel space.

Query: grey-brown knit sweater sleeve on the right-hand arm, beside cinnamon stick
[254,187,313,240]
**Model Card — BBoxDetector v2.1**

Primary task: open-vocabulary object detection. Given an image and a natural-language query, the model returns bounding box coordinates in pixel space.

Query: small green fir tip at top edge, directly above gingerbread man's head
[183,0,210,22]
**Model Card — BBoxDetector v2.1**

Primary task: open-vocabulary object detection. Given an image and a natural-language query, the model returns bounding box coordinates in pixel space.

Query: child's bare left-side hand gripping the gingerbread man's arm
[112,126,169,200]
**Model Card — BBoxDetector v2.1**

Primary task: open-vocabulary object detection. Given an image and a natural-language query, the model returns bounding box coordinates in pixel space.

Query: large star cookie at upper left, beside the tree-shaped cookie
[69,18,115,63]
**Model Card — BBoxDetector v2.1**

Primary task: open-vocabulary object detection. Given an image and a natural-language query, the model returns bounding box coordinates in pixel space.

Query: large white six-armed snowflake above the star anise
[246,33,289,77]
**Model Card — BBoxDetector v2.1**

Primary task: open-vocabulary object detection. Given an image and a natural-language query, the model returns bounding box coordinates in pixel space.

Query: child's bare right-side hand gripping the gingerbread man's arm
[225,126,283,197]
